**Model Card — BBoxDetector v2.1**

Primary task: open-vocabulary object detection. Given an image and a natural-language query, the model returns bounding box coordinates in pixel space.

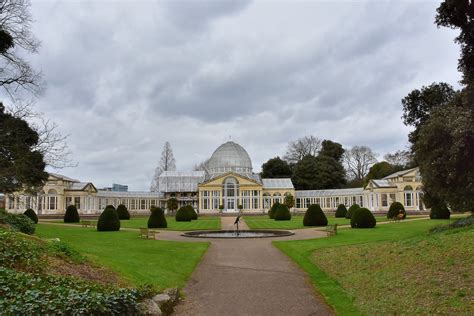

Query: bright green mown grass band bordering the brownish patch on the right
[274,220,456,315]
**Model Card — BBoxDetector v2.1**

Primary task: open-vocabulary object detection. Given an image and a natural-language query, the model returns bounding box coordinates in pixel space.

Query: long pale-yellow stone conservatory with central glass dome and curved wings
[5,141,424,214]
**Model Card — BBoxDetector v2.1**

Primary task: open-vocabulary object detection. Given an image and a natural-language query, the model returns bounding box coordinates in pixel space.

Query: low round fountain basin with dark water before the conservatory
[182,229,295,238]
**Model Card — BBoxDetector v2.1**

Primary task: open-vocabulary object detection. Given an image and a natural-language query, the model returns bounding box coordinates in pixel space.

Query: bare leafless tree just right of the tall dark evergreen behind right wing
[344,146,377,180]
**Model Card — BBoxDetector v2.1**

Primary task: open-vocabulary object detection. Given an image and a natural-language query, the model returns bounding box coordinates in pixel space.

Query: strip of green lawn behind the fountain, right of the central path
[244,215,394,229]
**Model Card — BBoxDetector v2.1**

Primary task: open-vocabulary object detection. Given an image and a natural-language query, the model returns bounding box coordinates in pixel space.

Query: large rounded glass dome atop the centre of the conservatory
[208,141,252,177]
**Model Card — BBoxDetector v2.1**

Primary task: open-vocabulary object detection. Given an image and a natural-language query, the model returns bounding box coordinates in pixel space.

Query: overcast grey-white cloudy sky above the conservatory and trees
[14,0,460,190]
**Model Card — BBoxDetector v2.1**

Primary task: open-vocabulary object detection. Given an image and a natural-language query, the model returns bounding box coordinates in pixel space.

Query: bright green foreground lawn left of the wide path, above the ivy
[36,224,209,289]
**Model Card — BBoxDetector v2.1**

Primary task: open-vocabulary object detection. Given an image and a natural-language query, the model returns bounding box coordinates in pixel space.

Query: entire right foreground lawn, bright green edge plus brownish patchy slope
[274,220,474,315]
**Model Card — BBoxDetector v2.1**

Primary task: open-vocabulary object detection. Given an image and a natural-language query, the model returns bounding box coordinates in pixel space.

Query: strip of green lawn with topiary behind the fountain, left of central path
[46,216,221,231]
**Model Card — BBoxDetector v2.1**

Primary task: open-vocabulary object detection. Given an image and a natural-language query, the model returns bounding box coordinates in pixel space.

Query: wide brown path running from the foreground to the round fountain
[175,217,334,315]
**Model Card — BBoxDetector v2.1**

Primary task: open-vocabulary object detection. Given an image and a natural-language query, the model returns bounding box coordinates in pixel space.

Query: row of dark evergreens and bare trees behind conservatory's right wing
[261,135,414,190]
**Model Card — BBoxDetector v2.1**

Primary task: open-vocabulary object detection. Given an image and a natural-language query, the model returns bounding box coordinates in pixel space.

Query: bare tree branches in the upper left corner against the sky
[0,0,44,98]
